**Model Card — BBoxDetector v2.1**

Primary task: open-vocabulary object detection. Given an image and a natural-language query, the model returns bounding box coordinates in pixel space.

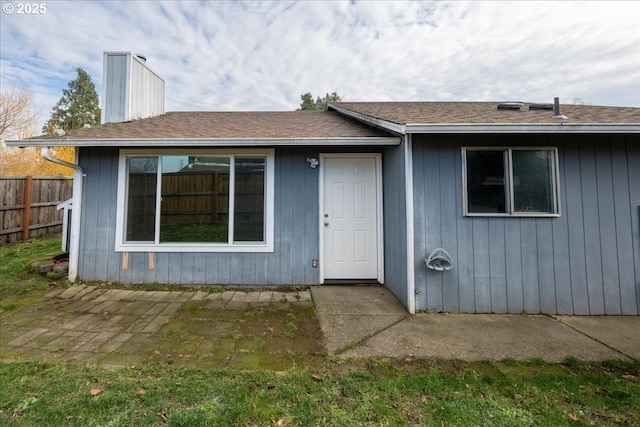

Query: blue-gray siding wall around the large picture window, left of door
[78,147,384,286]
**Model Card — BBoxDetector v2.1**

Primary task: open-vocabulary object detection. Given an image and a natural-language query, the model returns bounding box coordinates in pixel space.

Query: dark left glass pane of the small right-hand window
[467,150,507,213]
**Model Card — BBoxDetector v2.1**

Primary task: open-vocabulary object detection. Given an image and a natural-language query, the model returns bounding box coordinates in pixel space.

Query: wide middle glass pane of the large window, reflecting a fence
[160,156,230,243]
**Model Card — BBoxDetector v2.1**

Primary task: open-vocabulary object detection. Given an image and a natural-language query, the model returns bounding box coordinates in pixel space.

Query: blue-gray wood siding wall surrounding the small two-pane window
[413,135,640,315]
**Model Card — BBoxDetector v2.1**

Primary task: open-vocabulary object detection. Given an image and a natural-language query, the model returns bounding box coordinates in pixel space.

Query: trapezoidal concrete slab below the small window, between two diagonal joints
[343,314,621,362]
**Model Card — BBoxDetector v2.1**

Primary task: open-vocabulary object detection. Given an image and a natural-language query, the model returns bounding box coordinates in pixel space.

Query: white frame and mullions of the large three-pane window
[115,149,275,252]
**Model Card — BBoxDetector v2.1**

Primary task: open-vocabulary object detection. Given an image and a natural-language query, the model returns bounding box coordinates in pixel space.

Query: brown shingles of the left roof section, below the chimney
[12,111,400,145]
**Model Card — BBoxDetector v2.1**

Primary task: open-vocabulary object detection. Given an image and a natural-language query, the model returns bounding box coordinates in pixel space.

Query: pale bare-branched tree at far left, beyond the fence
[0,86,38,139]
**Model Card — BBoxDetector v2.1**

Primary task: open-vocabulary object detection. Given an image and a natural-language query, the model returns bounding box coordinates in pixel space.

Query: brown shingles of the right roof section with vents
[329,102,640,130]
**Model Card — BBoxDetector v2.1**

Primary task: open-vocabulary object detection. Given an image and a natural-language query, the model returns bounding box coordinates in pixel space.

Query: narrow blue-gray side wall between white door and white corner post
[382,140,409,306]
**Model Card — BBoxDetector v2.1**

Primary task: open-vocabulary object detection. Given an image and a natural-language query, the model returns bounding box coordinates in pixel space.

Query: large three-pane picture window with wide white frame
[116,150,273,252]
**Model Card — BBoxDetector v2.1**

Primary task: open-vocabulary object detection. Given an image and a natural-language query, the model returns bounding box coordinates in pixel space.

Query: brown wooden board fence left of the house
[0,176,73,243]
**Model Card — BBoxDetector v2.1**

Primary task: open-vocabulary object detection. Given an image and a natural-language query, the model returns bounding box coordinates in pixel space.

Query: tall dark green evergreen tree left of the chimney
[42,68,100,134]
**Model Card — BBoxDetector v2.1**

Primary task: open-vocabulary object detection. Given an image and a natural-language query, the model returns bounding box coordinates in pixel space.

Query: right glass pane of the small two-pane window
[512,150,554,213]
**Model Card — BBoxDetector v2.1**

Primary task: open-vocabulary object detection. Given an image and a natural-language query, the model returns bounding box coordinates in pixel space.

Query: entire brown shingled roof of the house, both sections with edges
[7,102,640,146]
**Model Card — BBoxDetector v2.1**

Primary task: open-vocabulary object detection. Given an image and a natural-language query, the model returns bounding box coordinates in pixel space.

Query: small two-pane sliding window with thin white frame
[462,147,560,217]
